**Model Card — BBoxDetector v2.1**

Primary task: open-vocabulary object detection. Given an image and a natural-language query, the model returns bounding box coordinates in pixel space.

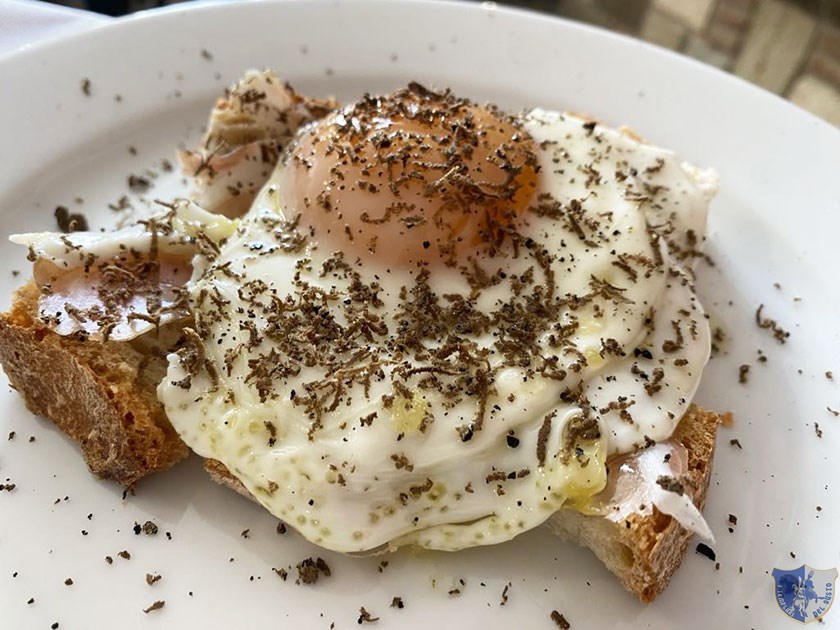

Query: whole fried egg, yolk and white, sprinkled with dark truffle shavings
[158,84,716,553]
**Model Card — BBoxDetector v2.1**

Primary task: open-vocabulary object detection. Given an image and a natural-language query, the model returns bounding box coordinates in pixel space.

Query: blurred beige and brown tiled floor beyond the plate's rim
[47,0,840,127]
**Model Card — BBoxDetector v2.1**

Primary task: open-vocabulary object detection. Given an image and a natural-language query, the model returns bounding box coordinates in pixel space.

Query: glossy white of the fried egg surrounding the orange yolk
[158,105,715,552]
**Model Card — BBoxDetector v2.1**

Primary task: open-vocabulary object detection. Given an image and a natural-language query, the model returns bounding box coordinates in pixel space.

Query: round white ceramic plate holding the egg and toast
[0,0,840,629]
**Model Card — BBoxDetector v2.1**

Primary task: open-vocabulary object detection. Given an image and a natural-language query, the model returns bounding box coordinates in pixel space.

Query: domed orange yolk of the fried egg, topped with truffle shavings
[280,84,538,265]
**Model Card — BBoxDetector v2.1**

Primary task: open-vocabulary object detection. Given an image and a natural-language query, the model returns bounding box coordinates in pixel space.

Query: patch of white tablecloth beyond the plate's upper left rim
[0,0,111,56]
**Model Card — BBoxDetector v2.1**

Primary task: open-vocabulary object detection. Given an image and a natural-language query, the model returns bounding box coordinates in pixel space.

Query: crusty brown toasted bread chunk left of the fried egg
[0,281,189,487]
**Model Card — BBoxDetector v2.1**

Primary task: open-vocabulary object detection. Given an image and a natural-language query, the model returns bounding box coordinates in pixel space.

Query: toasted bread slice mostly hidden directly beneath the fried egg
[204,405,720,603]
